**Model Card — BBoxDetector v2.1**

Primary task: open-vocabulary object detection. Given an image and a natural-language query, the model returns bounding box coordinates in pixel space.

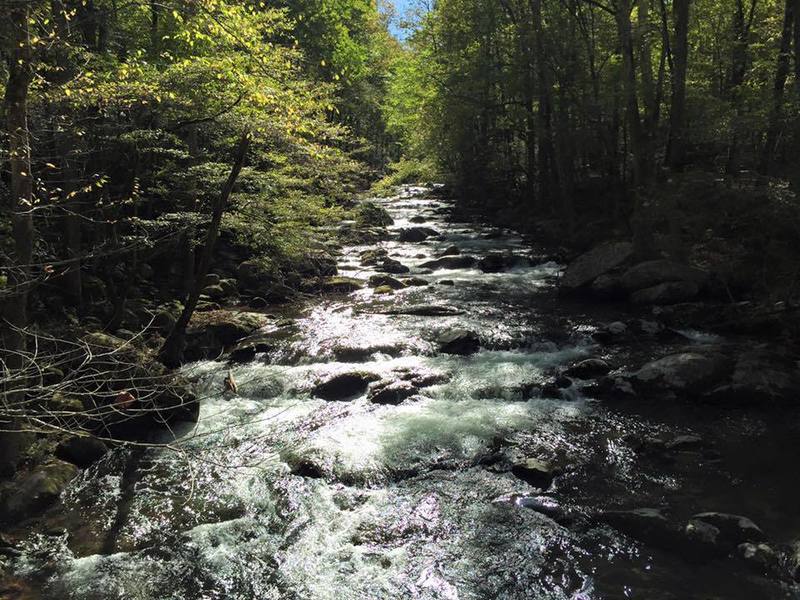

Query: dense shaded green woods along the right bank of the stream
[387,0,800,268]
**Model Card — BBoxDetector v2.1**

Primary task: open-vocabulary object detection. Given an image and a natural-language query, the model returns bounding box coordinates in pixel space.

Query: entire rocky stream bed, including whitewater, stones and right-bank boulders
[0,189,800,600]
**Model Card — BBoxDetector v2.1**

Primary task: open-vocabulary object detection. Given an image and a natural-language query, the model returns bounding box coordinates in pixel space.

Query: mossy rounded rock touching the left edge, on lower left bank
[0,460,78,523]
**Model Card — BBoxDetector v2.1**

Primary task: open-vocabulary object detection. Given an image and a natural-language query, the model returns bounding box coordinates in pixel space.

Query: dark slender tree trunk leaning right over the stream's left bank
[160,133,250,367]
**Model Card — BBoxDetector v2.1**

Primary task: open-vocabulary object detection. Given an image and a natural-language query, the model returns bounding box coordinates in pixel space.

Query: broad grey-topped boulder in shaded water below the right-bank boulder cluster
[632,352,729,396]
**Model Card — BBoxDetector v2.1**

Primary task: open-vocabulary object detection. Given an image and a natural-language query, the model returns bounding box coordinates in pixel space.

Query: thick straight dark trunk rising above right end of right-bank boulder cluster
[667,0,690,170]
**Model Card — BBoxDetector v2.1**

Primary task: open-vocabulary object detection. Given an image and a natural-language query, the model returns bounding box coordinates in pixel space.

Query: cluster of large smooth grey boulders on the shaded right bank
[560,242,711,305]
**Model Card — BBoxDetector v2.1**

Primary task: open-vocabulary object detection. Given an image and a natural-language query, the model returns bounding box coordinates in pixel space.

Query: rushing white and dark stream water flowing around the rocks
[9,190,800,600]
